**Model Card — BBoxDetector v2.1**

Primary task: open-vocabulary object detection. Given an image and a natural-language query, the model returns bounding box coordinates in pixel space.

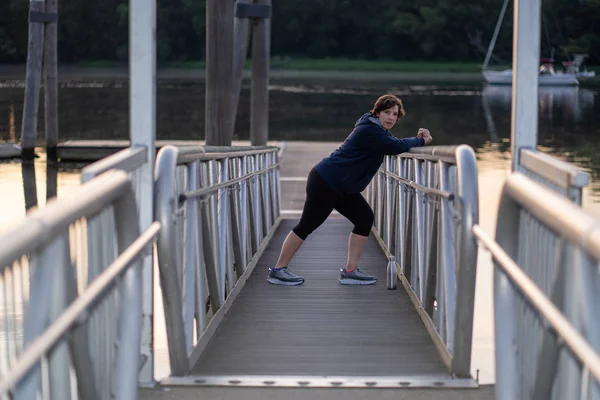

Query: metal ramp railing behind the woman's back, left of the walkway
[155,146,280,376]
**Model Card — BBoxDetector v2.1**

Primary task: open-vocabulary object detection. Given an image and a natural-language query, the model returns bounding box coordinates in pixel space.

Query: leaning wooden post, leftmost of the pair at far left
[21,0,45,160]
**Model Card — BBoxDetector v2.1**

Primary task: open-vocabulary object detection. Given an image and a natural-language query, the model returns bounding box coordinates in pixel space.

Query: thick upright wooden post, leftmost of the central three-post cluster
[205,0,235,146]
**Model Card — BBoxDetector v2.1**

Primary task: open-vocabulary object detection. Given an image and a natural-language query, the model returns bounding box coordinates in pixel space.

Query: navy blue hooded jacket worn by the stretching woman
[315,113,425,194]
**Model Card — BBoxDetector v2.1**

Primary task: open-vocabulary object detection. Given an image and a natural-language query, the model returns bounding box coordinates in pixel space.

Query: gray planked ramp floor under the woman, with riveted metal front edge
[161,217,477,387]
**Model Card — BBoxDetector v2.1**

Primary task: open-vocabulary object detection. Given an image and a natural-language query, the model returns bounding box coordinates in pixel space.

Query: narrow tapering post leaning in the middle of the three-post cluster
[231,0,252,135]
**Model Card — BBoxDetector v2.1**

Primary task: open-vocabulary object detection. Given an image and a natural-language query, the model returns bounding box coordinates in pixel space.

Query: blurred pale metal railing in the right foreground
[473,172,600,400]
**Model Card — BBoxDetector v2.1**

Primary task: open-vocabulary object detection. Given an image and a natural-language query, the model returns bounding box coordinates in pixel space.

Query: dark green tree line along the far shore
[0,0,600,64]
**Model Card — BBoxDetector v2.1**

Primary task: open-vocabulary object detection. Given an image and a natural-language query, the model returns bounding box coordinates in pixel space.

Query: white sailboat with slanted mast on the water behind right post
[482,0,595,86]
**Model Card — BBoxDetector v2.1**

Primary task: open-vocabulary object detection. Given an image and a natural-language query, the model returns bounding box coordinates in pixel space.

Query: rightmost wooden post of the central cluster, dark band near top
[250,0,271,146]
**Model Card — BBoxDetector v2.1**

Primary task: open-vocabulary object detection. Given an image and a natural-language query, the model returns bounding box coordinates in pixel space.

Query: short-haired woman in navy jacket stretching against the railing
[267,94,432,285]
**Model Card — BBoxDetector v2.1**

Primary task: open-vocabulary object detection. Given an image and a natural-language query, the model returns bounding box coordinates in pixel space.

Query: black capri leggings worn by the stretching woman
[292,168,374,240]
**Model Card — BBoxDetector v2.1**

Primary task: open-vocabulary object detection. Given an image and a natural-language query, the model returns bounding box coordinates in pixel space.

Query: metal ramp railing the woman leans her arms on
[367,145,479,377]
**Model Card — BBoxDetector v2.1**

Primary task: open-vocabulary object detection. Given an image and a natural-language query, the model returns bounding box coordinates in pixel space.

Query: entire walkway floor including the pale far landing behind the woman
[140,142,494,400]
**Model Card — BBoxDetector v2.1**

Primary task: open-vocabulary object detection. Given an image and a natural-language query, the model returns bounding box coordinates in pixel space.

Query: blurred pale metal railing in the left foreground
[0,171,160,400]
